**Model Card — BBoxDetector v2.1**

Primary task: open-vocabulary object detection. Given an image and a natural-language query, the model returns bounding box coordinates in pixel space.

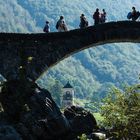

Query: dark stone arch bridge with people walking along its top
[0,21,140,80]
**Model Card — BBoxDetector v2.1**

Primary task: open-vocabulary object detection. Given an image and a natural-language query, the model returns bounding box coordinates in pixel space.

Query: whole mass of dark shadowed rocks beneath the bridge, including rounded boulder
[0,80,97,140]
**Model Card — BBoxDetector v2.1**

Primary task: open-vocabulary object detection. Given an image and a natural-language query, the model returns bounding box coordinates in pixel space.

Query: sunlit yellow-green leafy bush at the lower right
[101,85,140,139]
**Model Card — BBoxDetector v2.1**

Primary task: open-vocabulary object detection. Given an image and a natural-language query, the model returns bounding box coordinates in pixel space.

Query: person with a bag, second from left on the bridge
[56,16,68,32]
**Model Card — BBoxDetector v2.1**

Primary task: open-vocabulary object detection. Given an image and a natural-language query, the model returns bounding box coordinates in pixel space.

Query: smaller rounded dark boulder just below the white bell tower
[64,106,98,135]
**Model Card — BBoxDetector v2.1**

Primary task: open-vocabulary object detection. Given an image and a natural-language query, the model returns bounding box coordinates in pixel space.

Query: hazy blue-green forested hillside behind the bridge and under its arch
[0,0,140,104]
